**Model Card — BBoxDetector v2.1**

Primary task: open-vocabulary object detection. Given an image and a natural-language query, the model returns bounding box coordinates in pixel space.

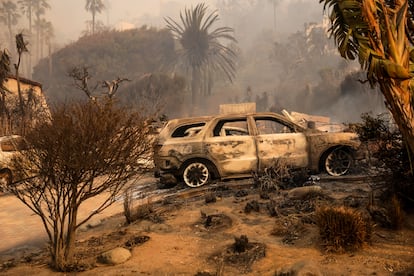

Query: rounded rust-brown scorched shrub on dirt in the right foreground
[315,206,372,252]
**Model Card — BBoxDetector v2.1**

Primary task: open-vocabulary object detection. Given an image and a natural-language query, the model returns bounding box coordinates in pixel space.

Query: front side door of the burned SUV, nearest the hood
[254,116,308,171]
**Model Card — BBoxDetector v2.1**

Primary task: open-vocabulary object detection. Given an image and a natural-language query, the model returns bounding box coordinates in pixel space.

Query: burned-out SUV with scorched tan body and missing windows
[154,112,360,187]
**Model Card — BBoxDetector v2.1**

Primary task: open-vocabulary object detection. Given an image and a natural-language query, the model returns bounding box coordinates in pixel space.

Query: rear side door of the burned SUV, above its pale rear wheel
[205,117,257,177]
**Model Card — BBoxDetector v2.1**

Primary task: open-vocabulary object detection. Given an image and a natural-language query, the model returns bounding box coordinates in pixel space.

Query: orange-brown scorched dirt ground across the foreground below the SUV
[0,176,414,276]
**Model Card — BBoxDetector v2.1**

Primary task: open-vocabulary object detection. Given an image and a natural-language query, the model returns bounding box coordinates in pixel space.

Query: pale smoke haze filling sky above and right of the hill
[1,0,385,122]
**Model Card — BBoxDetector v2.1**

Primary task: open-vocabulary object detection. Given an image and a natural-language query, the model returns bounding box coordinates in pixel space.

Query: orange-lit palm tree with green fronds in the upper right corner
[319,0,414,158]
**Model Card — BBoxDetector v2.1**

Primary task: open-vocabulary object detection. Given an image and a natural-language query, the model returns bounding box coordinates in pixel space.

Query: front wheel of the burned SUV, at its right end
[325,148,353,176]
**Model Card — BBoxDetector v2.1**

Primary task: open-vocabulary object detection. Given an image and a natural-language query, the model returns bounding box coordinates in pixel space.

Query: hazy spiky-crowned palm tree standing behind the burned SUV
[165,4,236,111]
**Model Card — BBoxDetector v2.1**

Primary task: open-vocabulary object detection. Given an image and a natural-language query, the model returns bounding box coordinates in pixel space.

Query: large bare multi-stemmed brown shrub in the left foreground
[9,100,151,271]
